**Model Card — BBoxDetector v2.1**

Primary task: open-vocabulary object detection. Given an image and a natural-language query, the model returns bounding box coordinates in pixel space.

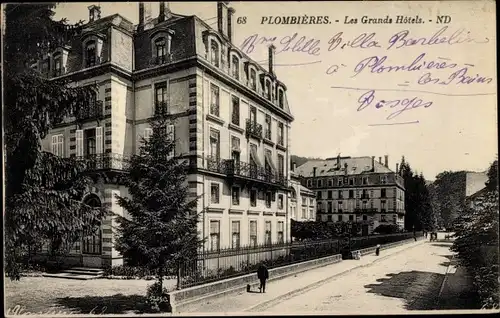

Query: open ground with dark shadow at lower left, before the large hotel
[4,277,176,315]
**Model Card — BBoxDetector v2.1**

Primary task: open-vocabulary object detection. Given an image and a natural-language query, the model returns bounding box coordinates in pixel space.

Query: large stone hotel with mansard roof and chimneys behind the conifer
[33,2,293,267]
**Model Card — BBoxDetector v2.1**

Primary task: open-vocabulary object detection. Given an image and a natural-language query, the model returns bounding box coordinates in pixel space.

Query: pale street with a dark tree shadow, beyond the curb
[252,238,452,314]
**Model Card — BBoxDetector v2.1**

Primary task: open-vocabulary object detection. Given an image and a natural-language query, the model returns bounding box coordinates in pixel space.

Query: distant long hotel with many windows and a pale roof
[297,156,405,235]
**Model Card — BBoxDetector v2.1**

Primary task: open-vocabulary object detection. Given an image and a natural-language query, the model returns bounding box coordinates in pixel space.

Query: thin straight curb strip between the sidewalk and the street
[242,240,425,312]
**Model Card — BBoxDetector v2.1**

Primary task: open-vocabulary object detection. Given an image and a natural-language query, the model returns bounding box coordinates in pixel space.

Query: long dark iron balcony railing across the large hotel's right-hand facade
[207,157,286,186]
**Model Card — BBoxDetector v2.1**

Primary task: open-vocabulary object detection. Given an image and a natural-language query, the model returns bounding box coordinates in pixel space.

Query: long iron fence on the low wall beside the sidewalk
[180,232,423,288]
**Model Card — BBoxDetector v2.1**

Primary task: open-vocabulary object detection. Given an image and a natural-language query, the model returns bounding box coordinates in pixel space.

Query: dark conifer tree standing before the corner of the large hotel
[115,118,201,291]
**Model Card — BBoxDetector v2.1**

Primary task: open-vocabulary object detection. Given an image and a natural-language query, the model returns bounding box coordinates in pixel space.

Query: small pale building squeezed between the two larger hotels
[289,164,316,222]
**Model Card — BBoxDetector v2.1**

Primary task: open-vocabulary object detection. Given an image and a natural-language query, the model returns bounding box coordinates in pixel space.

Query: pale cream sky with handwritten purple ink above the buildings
[52,1,498,180]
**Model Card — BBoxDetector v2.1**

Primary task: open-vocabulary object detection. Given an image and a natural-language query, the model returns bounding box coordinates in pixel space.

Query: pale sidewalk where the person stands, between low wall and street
[178,240,425,314]
